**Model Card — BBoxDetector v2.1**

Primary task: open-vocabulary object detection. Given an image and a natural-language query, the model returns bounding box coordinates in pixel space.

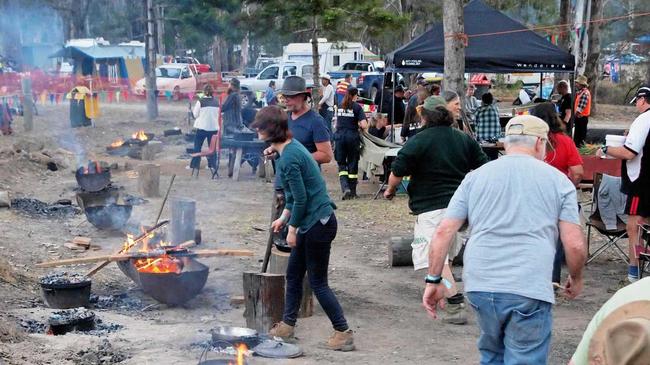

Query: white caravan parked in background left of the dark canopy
[282,38,376,74]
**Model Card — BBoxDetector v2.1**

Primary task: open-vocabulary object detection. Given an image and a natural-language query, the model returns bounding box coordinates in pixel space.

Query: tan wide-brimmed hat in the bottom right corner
[589,300,650,365]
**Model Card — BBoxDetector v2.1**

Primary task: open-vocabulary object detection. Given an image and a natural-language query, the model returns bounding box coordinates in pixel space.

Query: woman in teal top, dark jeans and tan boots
[251,106,354,351]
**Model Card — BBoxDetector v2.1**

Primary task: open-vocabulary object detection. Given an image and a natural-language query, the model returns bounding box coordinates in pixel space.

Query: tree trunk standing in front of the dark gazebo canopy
[442,0,465,105]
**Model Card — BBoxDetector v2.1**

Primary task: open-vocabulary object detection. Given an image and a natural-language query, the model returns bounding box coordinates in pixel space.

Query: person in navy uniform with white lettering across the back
[334,87,368,200]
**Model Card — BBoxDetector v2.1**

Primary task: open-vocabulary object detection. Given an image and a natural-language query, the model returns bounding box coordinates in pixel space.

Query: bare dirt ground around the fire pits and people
[0,103,635,365]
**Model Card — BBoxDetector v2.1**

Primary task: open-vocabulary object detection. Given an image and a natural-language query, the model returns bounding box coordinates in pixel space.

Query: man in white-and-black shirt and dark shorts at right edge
[597,85,650,282]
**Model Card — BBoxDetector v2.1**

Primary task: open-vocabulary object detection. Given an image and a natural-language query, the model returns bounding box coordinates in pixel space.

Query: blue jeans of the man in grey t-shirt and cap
[466,292,553,365]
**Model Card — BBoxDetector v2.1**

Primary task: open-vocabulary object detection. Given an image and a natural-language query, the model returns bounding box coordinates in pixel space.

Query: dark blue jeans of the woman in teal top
[282,214,348,331]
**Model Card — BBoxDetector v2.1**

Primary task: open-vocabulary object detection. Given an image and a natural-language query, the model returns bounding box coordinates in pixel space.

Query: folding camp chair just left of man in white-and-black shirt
[587,173,629,263]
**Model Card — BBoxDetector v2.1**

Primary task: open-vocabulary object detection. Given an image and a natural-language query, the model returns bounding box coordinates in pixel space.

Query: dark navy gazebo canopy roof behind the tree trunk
[386,0,575,73]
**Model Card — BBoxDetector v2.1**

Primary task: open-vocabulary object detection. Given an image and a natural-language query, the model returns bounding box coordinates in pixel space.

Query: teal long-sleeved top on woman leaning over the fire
[277,139,336,232]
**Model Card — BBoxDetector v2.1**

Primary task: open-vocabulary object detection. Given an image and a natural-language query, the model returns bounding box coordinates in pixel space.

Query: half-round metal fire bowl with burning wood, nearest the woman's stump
[117,257,209,306]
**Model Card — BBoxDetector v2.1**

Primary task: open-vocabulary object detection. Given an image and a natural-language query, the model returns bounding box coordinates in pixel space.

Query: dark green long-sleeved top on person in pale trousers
[392,126,488,214]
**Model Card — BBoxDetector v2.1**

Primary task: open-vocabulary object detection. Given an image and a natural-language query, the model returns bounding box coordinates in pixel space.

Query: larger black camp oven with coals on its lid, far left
[40,272,91,309]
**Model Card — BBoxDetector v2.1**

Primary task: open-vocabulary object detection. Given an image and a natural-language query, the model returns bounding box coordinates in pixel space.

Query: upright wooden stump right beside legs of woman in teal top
[243,272,284,333]
